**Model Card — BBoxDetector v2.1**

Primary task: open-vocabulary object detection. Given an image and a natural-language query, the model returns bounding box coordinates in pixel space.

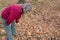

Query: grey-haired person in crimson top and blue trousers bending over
[1,3,31,40]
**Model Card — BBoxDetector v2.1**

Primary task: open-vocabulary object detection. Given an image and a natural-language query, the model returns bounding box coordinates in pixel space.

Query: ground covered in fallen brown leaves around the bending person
[0,0,60,40]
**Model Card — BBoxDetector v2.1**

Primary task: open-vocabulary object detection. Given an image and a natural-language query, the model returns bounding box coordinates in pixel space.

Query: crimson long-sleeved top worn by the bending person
[1,4,22,25]
